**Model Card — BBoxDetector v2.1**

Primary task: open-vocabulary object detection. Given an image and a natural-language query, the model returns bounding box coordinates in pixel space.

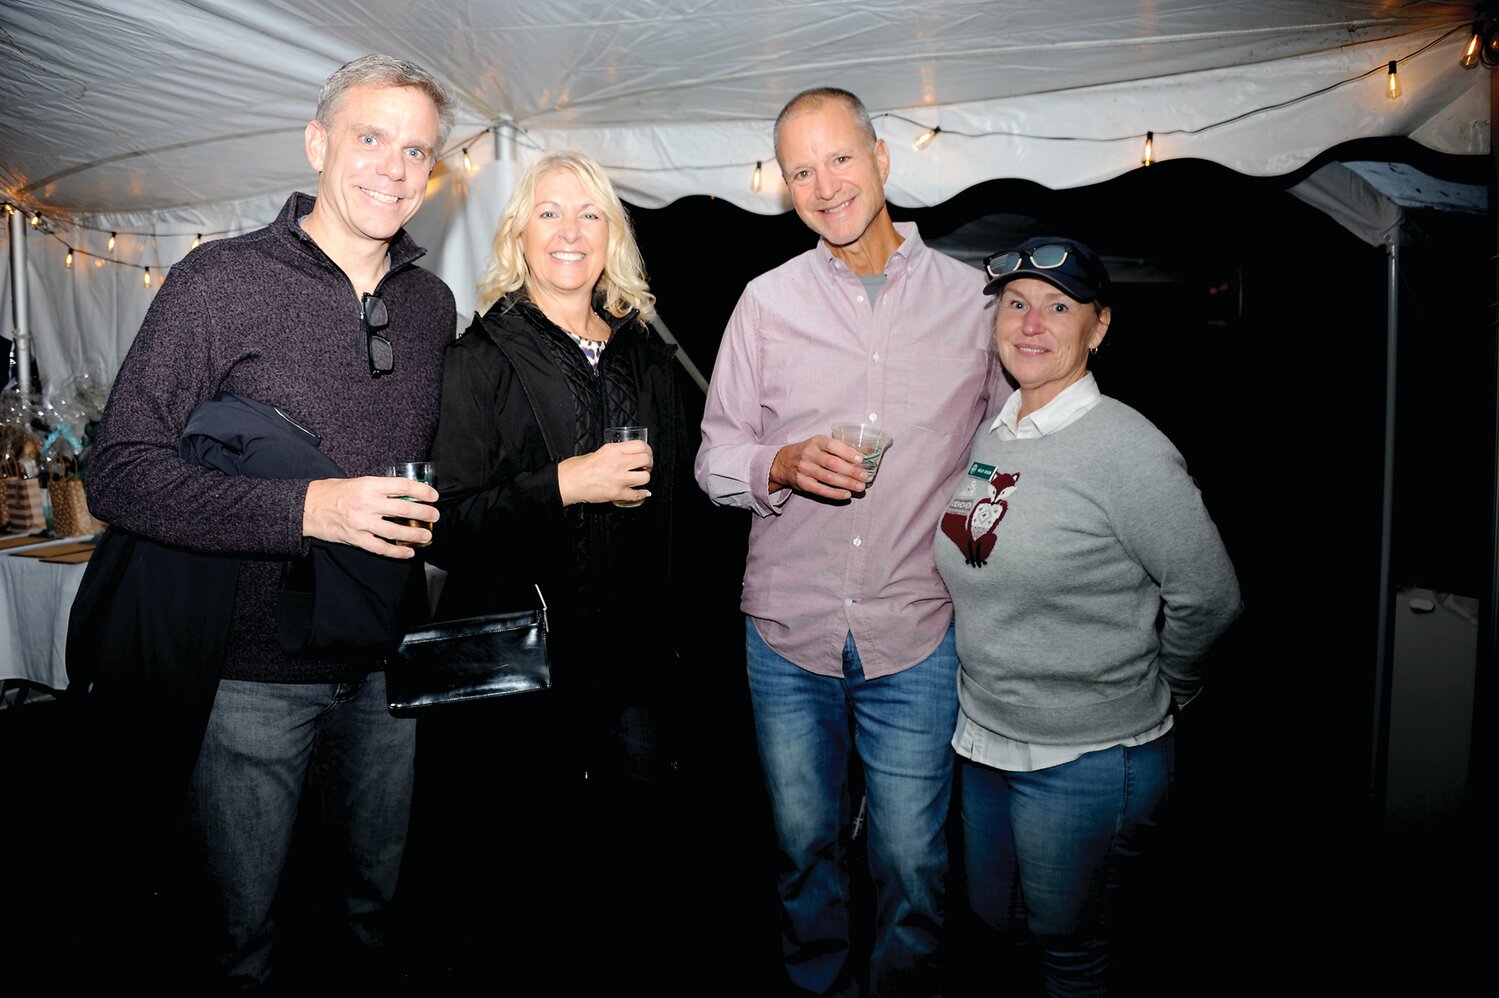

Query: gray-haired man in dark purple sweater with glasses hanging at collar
[88,55,456,986]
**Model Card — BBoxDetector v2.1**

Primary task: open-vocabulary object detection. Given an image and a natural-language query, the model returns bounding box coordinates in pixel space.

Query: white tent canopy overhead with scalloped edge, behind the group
[0,0,1489,395]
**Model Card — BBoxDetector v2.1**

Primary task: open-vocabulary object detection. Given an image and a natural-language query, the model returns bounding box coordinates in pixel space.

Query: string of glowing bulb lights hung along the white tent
[0,16,1499,288]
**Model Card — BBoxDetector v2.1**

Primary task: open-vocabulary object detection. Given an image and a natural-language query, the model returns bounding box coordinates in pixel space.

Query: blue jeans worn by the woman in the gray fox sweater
[958,731,1175,995]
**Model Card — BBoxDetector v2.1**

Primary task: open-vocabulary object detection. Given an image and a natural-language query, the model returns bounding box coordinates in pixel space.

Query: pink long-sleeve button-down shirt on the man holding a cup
[696,223,1009,679]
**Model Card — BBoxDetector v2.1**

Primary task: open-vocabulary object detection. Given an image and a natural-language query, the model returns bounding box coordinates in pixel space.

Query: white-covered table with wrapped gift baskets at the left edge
[0,391,105,694]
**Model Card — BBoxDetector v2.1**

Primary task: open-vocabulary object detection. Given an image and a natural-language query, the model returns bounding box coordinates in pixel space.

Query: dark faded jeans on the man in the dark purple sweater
[190,673,417,983]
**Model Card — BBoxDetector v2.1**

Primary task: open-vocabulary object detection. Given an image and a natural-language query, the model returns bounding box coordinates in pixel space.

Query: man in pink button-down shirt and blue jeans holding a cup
[696,88,1009,998]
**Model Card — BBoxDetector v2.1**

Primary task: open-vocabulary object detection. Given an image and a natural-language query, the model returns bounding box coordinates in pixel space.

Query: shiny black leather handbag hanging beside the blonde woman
[385,587,552,716]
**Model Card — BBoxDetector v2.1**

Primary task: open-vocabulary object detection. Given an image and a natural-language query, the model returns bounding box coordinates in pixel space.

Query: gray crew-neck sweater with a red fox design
[935,399,1241,745]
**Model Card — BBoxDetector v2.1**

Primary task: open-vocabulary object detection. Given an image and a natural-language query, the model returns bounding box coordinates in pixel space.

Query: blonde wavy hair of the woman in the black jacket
[478,153,655,322]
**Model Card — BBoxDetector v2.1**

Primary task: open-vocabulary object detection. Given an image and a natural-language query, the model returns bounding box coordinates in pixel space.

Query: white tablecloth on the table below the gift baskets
[0,533,88,689]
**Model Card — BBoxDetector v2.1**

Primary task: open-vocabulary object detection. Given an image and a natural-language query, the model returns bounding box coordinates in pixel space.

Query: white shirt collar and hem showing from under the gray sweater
[952,375,1171,773]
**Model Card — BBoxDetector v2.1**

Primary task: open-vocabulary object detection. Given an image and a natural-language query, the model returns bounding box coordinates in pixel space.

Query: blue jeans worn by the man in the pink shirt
[745,620,958,997]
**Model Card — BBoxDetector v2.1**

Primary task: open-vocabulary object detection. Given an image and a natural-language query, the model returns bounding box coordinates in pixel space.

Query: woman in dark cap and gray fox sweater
[935,237,1240,995]
